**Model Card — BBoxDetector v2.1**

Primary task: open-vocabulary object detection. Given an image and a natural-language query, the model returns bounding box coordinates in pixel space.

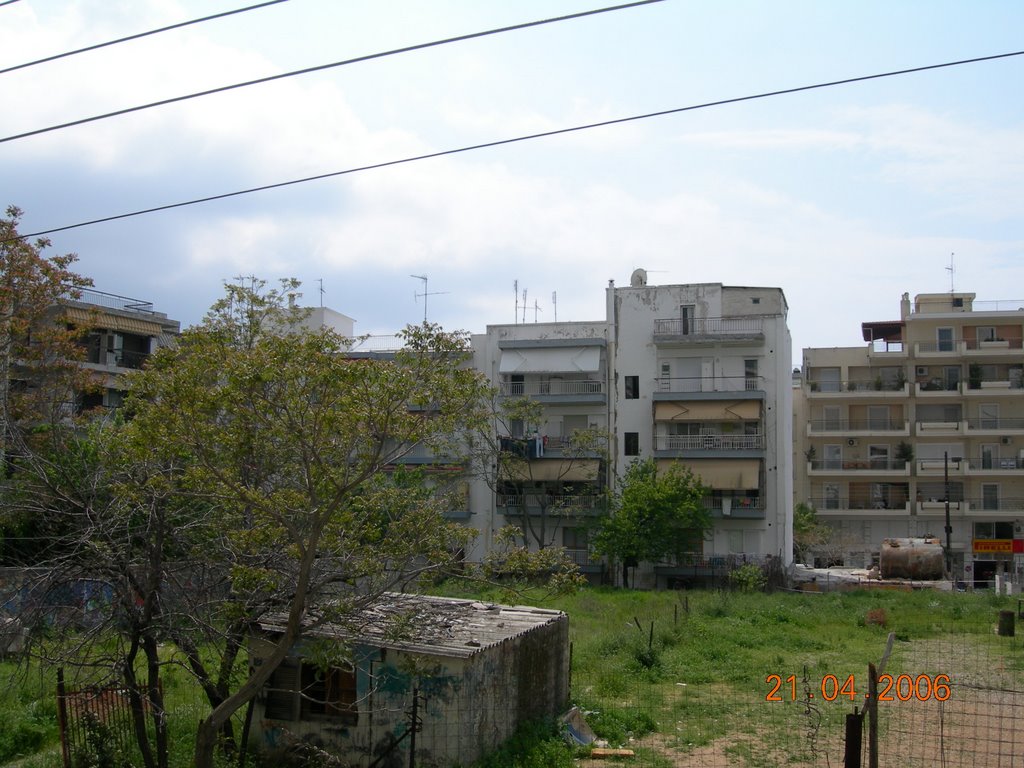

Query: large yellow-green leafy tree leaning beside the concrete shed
[117,281,486,768]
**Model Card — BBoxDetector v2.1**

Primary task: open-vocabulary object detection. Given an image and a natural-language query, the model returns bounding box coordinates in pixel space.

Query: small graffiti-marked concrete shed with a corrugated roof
[250,594,569,768]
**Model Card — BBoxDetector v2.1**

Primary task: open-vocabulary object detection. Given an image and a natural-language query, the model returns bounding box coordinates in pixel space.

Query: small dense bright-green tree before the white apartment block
[595,459,711,586]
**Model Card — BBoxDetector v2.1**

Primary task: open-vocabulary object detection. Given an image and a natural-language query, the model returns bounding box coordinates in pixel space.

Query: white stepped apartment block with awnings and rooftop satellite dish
[471,269,793,584]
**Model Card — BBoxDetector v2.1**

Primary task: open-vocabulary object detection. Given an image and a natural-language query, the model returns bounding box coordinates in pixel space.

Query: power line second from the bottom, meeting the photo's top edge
[0,0,665,143]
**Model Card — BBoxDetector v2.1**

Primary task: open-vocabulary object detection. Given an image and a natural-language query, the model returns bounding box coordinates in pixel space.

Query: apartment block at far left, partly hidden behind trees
[61,289,181,410]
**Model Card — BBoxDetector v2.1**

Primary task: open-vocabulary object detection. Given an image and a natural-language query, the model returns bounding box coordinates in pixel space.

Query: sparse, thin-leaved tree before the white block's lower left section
[481,397,607,550]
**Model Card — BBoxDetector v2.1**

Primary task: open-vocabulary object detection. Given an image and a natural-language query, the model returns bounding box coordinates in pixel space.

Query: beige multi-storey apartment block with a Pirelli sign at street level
[795,292,1024,585]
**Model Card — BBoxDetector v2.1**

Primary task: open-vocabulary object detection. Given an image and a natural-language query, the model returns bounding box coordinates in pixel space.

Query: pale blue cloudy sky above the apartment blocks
[0,0,1024,362]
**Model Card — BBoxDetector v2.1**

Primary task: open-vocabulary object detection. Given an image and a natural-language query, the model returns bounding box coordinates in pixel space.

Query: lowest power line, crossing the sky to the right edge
[8,50,1024,242]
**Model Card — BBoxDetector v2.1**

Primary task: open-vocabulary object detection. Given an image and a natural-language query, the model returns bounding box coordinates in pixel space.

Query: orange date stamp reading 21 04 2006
[765,674,952,701]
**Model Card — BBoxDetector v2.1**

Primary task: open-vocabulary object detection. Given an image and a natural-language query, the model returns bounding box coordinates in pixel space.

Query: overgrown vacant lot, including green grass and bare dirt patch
[0,589,1024,768]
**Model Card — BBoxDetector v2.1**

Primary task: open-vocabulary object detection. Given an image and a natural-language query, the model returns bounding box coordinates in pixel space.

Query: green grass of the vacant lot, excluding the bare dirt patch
[0,589,1024,768]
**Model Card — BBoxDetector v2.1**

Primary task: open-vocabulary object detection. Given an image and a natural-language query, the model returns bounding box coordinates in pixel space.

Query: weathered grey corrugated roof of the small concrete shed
[260,593,566,657]
